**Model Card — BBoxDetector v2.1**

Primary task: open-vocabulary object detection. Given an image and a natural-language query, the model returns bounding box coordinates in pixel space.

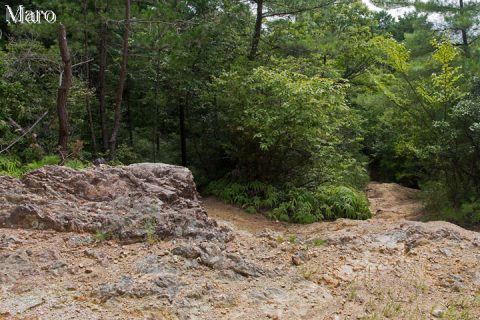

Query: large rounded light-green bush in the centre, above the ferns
[211,60,364,185]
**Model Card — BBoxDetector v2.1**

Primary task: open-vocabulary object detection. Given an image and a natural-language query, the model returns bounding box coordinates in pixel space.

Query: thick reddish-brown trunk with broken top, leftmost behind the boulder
[57,24,73,163]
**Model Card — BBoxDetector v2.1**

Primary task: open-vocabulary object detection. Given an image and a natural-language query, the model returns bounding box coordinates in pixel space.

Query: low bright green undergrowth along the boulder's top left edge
[0,155,88,178]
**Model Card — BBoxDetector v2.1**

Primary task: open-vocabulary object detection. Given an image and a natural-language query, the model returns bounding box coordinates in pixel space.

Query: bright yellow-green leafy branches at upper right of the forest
[372,36,465,124]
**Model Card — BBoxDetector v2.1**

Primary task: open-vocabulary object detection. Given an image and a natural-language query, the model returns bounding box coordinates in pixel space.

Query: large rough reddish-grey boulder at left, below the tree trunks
[0,163,231,242]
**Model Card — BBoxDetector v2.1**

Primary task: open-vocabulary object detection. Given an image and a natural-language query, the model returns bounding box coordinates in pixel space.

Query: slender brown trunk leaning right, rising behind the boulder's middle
[110,0,130,160]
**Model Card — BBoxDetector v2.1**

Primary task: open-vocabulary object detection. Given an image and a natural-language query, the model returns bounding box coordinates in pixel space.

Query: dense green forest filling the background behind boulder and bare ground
[0,0,480,225]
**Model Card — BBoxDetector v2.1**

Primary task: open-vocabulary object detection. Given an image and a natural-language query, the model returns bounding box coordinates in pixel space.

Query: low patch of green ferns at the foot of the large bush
[206,179,371,224]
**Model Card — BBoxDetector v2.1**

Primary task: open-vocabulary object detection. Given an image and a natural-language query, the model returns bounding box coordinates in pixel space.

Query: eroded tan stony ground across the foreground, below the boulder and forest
[0,172,480,319]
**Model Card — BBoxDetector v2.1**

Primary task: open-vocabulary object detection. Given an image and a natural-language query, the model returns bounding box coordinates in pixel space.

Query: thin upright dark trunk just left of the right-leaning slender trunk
[97,16,108,152]
